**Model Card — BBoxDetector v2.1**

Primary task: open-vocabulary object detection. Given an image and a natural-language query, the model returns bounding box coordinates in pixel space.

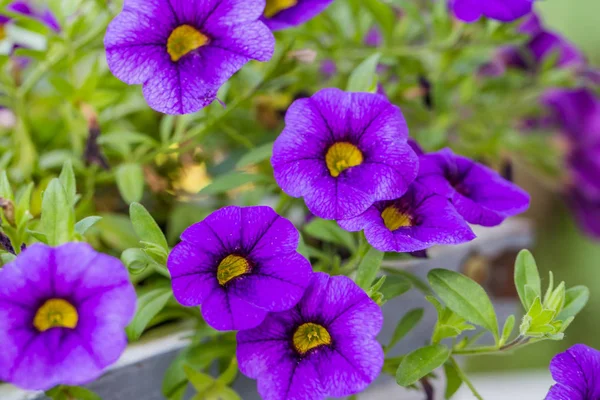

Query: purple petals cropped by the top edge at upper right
[450,0,534,22]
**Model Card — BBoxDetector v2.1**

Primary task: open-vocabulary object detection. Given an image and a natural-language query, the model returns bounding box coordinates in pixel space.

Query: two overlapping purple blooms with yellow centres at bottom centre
[167,206,383,400]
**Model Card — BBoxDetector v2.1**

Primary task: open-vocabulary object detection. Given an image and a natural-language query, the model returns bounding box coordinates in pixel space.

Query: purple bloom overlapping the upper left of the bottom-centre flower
[167,206,312,330]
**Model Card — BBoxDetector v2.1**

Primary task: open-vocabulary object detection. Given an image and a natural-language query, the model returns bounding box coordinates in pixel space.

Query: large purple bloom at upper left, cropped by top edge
[104,0,275,114]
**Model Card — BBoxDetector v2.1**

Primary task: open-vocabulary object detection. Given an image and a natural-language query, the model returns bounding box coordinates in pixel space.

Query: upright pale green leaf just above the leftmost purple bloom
[41,178,75,246]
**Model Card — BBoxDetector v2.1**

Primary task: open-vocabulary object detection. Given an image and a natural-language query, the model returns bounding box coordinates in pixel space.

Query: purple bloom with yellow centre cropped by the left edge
[0,243,136,390]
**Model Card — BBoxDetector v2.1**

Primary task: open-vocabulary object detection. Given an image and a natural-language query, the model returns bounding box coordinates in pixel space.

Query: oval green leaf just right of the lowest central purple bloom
[396,344,450,387]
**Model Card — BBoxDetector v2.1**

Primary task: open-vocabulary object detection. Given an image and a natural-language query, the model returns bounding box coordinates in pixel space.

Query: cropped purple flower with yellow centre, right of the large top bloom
[262,0,333,31]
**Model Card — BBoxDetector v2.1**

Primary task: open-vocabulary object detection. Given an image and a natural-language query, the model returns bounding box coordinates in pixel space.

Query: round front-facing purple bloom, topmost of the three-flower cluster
[271,89,418,219]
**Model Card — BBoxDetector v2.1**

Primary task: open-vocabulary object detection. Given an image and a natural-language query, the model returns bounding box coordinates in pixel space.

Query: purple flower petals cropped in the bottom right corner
[546,344,600,400]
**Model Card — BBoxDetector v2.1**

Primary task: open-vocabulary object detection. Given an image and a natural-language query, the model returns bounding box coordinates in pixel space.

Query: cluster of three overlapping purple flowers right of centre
[271,89,529,252]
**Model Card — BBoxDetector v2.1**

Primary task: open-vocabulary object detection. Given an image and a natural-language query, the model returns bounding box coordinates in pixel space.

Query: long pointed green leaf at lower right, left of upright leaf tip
[427,269,498,342]
